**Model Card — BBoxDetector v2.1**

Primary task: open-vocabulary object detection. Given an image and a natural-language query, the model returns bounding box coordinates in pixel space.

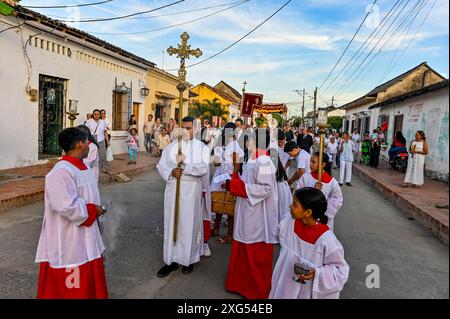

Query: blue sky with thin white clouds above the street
[21,0,449,115]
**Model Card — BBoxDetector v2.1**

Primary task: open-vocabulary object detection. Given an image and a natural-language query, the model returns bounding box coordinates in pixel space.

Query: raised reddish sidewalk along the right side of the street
[353,160,449,245]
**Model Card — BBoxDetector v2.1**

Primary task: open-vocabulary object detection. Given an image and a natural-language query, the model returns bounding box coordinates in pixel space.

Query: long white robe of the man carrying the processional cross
[156,139,209,266]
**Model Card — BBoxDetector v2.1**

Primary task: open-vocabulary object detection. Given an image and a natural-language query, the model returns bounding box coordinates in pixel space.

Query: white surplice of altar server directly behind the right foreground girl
[297,173,344,231]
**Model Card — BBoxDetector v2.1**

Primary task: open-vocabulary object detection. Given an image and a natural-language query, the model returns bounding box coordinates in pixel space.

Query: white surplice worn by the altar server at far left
[36,160,105,268]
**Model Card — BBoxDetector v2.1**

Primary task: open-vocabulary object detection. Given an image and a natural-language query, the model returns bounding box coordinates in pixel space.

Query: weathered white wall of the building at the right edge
[378,88,449,181]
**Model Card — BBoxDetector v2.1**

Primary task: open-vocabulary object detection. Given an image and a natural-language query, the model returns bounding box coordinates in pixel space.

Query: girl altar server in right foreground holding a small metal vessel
[270,187,349,299]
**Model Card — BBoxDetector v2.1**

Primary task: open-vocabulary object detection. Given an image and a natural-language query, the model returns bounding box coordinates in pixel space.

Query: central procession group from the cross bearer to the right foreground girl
[157,117,349,299]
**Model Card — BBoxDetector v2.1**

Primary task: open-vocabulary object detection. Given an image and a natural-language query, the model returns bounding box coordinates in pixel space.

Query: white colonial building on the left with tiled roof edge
[0,7,154,169]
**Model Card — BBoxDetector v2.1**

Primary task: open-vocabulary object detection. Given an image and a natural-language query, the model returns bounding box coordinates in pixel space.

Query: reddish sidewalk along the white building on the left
[0,152,158,213]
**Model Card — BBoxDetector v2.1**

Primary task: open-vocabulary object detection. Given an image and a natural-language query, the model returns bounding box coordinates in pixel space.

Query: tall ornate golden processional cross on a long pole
[167,32,203,244]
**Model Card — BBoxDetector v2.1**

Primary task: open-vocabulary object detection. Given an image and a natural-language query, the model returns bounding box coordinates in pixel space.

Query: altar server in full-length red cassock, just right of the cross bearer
[225,129,278,299]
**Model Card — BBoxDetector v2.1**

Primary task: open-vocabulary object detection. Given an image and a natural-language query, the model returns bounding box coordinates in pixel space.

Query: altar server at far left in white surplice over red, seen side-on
[36,128,108,299]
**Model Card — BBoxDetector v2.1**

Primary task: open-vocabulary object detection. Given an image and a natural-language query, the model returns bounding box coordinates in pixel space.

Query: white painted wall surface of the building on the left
[0,17,146,169]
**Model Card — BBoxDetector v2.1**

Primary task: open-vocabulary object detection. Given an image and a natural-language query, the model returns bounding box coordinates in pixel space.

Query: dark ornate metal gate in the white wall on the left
[39,75,66,159]
